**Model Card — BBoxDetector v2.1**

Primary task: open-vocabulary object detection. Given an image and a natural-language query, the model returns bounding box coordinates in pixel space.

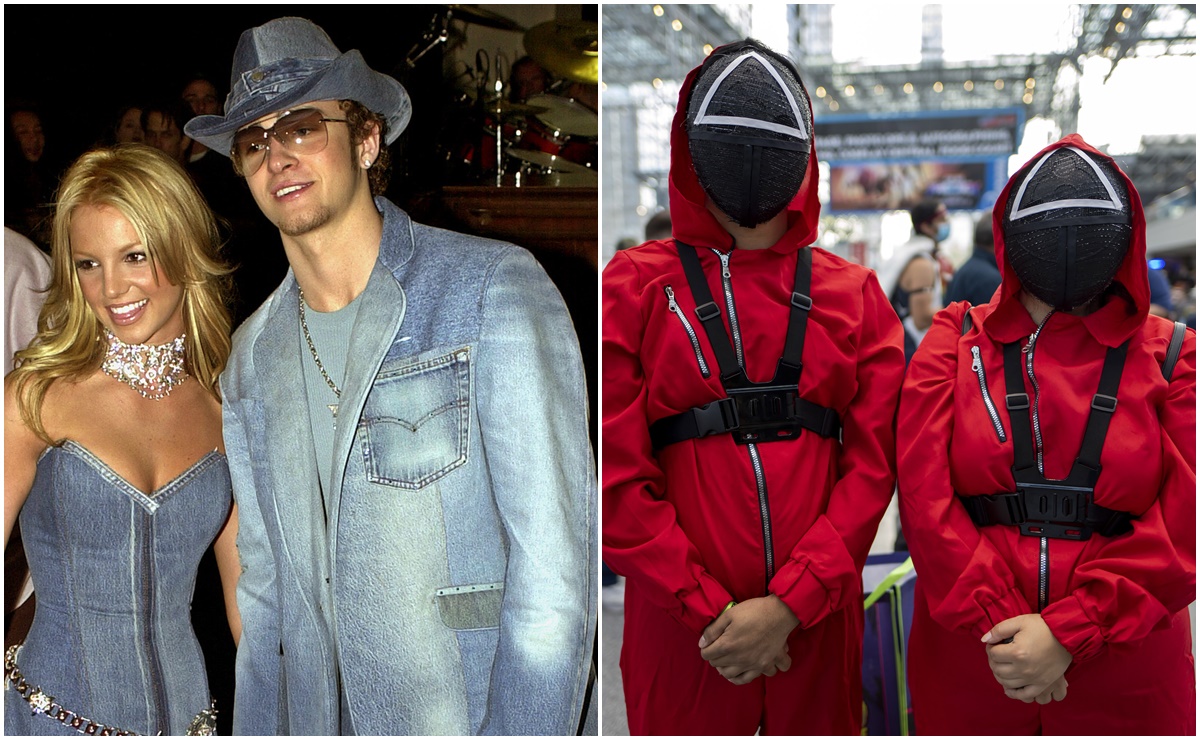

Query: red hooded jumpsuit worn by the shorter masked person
[896,136,1196,735]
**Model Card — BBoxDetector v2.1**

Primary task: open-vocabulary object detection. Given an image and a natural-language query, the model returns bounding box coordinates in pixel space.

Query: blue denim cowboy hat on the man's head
[184,18,413,157]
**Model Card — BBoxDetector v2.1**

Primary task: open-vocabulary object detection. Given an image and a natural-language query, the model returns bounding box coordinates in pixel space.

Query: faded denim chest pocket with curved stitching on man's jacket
[362,348,470,491]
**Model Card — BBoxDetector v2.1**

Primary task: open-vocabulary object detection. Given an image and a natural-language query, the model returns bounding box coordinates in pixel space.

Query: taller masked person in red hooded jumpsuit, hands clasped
[602,40,904,735]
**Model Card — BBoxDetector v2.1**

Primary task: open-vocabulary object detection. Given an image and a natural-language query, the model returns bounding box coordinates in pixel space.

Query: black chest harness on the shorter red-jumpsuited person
[959,312,1183,540]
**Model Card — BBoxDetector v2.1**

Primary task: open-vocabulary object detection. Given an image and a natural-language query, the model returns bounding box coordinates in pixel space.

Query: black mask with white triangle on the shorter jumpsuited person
[1003,146,1133,311]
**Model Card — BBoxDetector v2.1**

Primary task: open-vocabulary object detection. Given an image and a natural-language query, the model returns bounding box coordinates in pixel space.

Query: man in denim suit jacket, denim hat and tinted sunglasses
[186,18,596,735]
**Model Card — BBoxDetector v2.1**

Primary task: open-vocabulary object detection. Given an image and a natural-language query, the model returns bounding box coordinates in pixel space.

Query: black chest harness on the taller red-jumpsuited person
[650,240,841,450]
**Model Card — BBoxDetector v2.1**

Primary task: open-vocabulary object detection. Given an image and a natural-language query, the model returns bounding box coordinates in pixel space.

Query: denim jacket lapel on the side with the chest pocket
[329,261,406,561]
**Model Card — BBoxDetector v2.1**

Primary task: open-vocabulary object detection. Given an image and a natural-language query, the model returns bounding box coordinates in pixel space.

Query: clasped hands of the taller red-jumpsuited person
[700,594,800,685]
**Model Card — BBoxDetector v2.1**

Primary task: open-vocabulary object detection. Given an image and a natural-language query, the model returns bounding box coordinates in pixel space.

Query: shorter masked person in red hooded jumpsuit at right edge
[896,134,1196,735]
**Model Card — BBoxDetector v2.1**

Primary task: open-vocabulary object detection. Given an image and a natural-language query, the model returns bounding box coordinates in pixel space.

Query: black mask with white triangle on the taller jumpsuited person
[688,42,812,227]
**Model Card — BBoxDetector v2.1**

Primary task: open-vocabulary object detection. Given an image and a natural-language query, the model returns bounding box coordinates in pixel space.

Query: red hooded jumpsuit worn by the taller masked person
[602,53,904,735]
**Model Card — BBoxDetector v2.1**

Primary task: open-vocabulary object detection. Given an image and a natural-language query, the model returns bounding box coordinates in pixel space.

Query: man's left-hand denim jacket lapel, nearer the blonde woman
[253,273,329,583]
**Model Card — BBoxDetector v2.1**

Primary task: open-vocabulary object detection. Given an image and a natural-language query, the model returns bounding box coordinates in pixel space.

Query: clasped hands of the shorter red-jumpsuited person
[980,614,1070,704]
